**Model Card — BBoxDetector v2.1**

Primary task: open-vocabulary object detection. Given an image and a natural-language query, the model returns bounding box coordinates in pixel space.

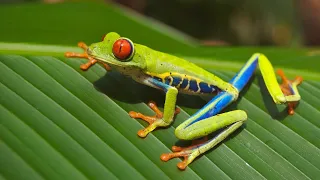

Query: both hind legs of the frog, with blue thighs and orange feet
[161,53,302,170]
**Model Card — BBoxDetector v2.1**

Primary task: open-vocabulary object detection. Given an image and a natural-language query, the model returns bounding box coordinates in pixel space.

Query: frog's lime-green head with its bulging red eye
[87,32,146,69]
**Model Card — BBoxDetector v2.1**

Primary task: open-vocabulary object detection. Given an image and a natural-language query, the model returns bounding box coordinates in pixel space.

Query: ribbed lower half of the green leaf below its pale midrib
[0,48,320,179]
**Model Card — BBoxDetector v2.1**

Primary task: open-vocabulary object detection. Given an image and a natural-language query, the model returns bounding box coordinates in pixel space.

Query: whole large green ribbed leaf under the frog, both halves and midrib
[0,1,320,179]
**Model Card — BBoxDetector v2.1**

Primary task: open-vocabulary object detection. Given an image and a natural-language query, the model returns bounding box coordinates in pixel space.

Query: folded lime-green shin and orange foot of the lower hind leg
[160,110,247,170]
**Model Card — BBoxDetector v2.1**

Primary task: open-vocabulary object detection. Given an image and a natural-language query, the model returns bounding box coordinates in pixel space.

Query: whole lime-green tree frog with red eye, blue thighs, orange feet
[65,32,302,170]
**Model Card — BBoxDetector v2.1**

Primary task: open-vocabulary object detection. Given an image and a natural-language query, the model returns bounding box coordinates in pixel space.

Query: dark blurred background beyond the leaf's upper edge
[0,0,320,46]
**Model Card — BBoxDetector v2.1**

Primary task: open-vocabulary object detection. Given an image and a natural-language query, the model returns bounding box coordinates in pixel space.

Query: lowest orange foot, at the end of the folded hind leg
[160,136,208,170]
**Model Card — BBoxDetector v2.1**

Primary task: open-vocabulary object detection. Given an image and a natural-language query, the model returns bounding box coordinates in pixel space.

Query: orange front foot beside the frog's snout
[64,42,111,71]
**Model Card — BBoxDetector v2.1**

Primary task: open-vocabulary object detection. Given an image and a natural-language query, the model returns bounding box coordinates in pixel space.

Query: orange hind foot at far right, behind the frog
[277,69,303,115]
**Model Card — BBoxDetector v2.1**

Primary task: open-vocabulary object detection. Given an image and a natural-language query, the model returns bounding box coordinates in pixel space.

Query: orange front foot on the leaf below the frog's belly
[129,101,180,138]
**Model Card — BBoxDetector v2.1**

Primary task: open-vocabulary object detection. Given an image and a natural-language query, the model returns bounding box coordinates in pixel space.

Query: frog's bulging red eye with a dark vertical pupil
[112,38,134,61]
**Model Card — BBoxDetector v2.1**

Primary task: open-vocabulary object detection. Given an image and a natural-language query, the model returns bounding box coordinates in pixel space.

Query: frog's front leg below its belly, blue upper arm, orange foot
[129,78,180,137]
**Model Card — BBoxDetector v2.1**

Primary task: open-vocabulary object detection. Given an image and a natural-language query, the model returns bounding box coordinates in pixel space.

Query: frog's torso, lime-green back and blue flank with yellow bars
[138,46,230,94]
